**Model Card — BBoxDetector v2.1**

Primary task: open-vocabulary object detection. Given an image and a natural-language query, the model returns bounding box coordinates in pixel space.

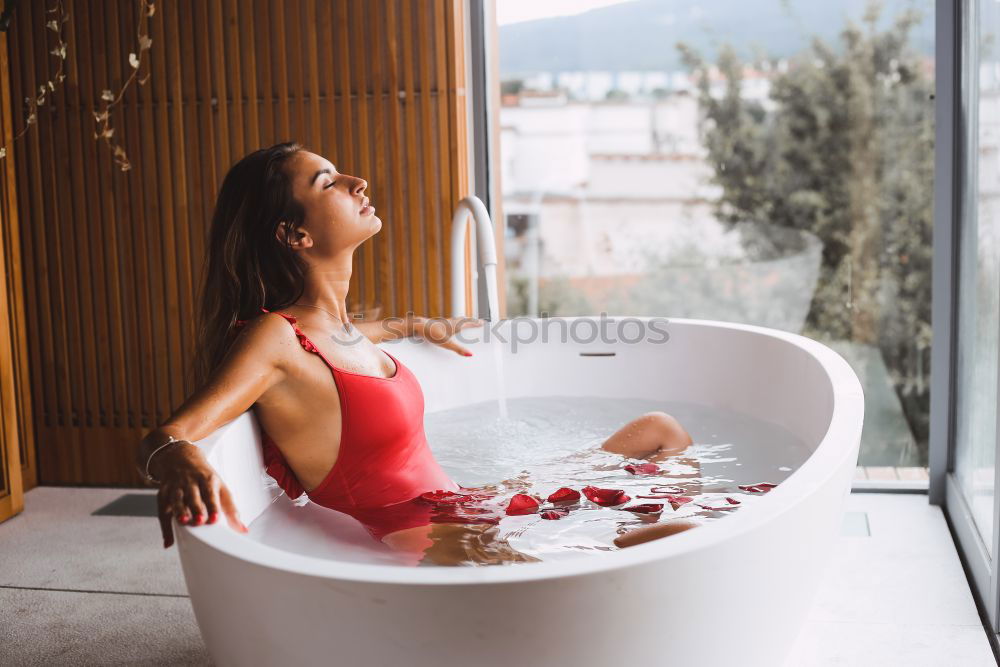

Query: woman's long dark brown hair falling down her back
[194,141,306,386]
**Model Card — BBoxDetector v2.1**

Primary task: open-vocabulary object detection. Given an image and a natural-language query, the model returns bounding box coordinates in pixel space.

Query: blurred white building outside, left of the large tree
[500,93,734,277]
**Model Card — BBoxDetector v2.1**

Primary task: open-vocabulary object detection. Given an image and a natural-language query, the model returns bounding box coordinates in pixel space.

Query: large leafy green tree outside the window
[678,2,934,464]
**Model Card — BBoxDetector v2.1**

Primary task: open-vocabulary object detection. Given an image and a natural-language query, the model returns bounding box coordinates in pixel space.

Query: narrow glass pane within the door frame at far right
[955,0,1000,556]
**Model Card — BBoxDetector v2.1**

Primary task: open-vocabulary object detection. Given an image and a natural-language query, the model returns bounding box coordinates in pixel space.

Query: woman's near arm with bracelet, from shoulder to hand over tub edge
[136,316,292,547]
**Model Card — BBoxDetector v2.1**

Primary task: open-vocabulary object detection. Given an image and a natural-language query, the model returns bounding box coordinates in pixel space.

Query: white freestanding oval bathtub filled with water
[174,318,864,667]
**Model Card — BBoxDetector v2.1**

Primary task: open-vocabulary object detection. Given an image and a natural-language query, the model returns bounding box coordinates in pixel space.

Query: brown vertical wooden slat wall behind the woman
[9,0,469,485]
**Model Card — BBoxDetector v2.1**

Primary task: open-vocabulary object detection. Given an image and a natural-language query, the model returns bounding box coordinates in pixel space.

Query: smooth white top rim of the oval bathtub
[172,316,864,586]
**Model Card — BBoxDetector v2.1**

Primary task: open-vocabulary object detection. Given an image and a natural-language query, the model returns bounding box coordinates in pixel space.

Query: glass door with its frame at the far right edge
[947,0,1000,632]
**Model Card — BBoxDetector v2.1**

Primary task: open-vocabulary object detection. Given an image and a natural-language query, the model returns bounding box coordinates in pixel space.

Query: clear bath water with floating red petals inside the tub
[250,397,810,567]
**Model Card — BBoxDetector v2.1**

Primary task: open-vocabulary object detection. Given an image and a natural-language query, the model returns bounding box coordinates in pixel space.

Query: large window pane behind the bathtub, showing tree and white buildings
[496,0,934,470]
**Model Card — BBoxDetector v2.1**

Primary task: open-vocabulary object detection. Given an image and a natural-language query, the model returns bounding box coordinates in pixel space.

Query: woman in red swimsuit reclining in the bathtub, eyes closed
[137,143,695,564]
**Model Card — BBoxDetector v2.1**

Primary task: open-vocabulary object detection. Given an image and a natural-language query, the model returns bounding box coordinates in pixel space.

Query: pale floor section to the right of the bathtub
[786,493,997,667]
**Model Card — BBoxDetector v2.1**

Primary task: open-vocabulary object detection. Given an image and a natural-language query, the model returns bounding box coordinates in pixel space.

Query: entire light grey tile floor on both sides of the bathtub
[0,487,996,667]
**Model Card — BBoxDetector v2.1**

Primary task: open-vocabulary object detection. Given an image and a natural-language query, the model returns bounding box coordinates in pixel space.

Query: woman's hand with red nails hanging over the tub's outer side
[154,442,247,549]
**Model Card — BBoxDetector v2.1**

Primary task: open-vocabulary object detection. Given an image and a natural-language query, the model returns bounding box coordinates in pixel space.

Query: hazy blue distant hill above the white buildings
[500,0,934,77]
